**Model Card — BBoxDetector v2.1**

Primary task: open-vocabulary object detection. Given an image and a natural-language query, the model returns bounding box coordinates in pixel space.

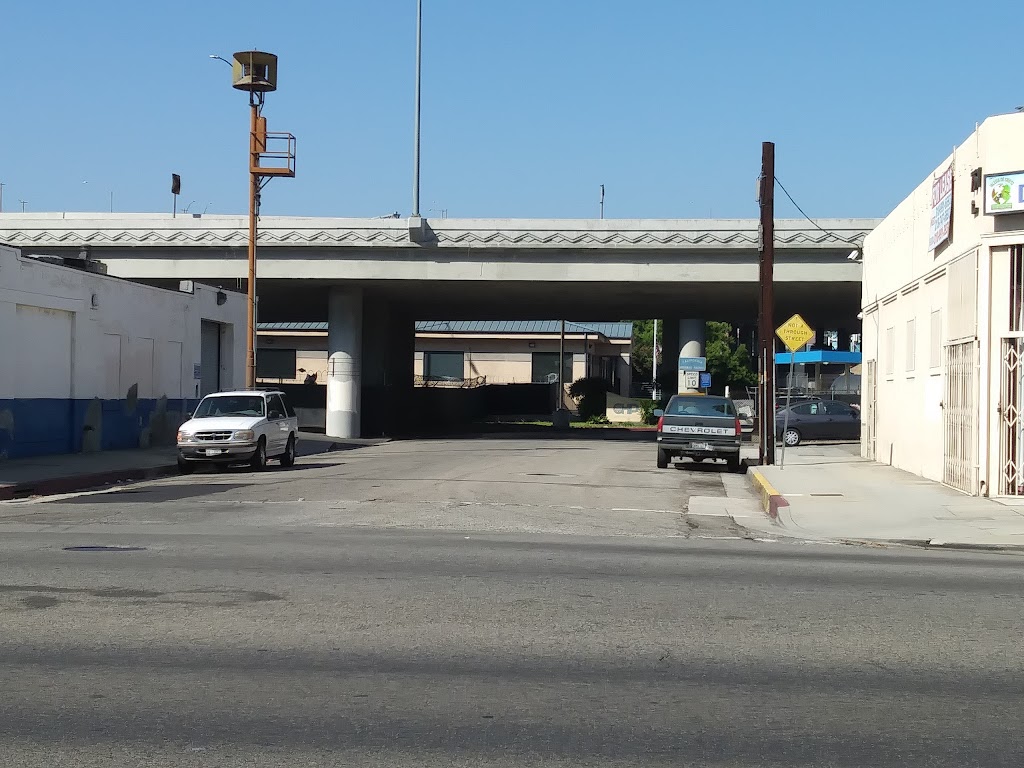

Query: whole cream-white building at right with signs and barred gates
[861,114,1024,496]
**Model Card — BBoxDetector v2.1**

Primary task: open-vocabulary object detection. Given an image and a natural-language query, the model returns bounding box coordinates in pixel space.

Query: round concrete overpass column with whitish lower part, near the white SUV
[327,288,362,437]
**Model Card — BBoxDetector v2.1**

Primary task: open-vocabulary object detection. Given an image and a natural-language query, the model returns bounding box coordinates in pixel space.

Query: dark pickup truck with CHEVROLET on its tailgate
[654,394,742,471]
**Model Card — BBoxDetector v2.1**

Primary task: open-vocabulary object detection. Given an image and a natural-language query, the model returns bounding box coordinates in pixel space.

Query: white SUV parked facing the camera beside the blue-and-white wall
[178,389,299,474]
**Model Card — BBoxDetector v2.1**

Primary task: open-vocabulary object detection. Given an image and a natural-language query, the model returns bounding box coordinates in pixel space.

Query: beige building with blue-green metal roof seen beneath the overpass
[257,321,633,395]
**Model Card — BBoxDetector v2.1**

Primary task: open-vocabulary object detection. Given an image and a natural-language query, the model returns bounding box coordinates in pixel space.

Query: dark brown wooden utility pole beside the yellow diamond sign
[758,141,775,464]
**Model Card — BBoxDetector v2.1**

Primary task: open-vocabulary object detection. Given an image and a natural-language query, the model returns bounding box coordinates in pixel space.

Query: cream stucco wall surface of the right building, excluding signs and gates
[862,114,1024,493]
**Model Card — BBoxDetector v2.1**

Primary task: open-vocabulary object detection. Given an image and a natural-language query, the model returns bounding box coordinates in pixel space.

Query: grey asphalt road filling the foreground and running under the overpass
[0,440,1024,768]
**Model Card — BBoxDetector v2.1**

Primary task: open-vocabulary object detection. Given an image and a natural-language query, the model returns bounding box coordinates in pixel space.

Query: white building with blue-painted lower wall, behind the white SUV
[0,246,246,460]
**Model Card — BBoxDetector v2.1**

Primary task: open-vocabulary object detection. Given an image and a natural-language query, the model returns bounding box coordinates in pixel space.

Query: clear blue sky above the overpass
[0,0,1024,218]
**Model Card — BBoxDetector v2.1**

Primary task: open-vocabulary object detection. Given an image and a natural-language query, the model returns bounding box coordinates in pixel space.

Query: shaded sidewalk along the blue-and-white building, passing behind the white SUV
[0,432,385,502]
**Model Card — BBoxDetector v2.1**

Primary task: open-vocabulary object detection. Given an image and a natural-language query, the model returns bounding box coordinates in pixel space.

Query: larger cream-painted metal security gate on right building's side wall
[942,341,978,494]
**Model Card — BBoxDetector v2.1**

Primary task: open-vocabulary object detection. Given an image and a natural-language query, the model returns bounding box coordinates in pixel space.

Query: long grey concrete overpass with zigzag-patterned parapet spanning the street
[0,213,878,437]
